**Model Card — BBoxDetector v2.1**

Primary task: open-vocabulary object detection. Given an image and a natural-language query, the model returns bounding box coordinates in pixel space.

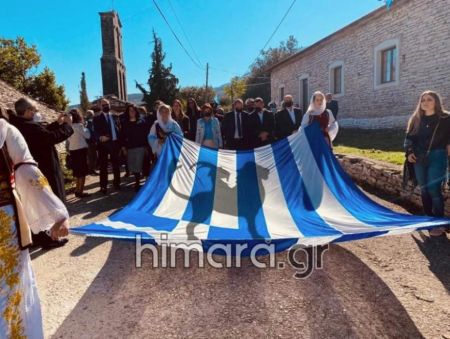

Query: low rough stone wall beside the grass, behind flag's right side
[336,154,450,215]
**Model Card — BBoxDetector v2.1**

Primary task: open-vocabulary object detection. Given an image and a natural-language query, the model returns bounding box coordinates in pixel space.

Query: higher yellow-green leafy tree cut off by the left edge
[0,37,41,91]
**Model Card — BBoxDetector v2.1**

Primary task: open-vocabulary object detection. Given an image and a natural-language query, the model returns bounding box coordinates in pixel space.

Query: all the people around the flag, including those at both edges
[0,91,450,336]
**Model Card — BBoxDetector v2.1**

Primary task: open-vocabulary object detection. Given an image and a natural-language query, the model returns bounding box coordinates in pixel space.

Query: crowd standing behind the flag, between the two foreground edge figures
[62,92,337,198]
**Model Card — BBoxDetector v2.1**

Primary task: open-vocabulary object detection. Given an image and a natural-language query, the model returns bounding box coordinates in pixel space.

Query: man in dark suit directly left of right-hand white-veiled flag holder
[275,94,303,139]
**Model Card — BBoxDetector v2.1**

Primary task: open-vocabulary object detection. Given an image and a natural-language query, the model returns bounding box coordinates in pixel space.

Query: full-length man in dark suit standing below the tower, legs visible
[94,99,121,194]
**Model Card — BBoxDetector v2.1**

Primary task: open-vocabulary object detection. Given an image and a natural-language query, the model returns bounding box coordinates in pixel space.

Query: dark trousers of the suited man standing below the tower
[98,141,120,189]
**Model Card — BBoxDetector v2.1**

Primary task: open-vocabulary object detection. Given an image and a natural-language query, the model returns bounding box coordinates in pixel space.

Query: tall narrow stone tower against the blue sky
[100,11,127,101]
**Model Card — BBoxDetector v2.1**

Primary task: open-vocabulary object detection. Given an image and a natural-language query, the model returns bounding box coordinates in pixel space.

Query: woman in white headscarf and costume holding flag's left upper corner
[148,104,183,158]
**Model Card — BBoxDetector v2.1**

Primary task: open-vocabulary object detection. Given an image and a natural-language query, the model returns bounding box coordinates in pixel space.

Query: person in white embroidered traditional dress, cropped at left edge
[0,110,69,339]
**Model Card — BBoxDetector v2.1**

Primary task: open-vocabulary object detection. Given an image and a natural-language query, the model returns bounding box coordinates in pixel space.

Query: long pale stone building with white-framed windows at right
[270,0,450,128]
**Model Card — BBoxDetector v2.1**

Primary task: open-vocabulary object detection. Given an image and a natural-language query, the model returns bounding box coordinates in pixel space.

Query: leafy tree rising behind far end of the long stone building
[244,35,300,103]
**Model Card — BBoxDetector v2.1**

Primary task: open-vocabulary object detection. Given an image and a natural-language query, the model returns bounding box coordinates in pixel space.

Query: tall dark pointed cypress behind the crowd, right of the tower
[136,31,178,107]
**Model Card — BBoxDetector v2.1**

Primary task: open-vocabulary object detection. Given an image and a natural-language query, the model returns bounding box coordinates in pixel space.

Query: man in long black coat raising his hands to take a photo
[9,98,73,249]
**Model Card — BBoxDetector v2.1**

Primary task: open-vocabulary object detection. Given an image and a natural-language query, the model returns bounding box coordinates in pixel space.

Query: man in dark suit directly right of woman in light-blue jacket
[222,99,250,150]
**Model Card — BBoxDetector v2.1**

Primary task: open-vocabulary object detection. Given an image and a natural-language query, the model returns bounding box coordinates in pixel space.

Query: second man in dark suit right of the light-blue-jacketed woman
[249,98,275,148]
